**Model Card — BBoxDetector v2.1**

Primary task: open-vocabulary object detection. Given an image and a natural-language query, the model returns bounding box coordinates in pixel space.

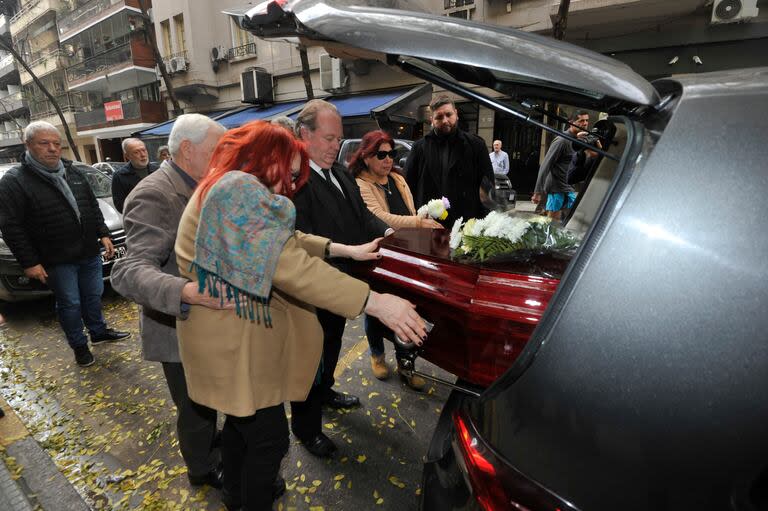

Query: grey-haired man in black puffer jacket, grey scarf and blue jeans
[0,121,130,367]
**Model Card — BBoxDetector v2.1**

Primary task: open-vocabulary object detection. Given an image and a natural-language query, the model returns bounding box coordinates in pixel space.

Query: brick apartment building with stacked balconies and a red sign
[56,0,168,162]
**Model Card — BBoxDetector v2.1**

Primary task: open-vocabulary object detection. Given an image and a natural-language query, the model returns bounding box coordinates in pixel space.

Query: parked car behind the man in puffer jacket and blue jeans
[0,162,125,302]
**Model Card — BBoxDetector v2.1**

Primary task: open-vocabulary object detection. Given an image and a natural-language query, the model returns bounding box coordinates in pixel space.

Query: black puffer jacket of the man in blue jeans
[0,160,109,268]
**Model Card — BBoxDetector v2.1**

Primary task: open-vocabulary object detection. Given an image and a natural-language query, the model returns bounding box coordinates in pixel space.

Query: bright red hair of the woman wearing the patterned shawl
[199,121,309,207]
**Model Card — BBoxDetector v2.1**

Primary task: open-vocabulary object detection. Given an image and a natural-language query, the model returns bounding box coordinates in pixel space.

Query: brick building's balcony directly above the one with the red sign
[67,38,157,94]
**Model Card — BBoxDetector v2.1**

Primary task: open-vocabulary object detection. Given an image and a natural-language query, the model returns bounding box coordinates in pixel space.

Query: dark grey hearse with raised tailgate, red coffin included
[231,0,768,511]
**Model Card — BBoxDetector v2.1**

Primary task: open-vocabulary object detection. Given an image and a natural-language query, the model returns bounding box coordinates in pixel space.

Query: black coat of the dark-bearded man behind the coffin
[405,130,494,227]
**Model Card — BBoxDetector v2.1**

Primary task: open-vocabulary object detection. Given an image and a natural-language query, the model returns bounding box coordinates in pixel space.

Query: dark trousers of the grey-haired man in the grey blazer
[163,362,219,476]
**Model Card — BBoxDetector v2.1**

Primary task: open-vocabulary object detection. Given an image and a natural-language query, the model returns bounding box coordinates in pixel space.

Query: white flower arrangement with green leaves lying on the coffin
[450,211,579,261]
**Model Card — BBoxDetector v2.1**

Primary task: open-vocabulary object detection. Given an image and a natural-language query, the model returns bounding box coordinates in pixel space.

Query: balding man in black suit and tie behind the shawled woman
[291,99,390,457]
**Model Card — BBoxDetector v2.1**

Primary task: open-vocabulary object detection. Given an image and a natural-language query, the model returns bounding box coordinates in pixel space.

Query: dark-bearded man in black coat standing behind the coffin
[405,96,494,227]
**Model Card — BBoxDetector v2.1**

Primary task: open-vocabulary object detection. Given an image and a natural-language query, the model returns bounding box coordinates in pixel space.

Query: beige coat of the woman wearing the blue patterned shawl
[176,191,369,417]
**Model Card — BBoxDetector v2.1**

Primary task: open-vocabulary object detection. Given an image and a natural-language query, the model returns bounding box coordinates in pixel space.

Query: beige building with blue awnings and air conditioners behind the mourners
[141,0,431,152]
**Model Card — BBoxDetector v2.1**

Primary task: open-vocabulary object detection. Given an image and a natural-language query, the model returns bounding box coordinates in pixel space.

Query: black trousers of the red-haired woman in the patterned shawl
[221,404,288,511]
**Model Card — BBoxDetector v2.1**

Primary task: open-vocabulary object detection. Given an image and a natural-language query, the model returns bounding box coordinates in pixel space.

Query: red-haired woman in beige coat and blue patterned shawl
[176,121,425,510]
